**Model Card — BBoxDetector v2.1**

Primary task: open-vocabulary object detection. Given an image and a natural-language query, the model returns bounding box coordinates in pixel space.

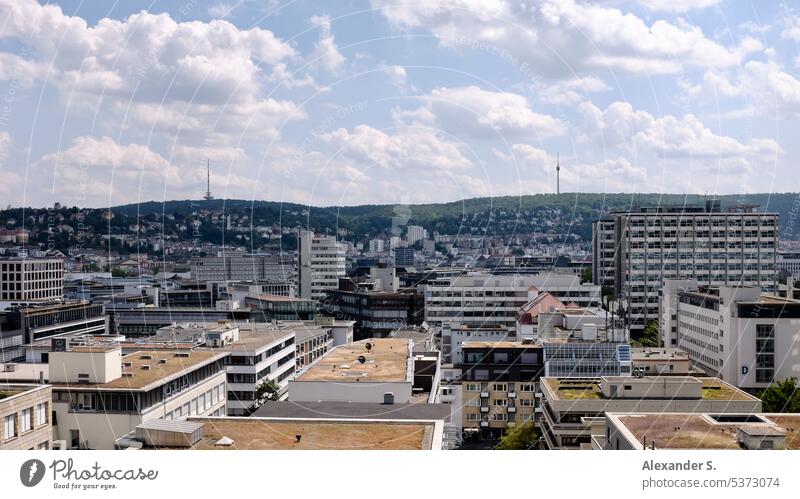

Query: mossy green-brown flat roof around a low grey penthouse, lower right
[541,376,757,400]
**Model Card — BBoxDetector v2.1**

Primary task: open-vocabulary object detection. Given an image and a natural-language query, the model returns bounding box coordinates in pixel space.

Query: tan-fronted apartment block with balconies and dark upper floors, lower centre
[461,341,544,440]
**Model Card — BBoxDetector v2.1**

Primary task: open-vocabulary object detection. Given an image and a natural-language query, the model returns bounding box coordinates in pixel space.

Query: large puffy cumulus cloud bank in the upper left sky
[0,0,302,141]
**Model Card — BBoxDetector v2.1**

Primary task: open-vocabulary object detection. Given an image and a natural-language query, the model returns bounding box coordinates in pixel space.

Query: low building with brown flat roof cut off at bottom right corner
[592,413,800,450]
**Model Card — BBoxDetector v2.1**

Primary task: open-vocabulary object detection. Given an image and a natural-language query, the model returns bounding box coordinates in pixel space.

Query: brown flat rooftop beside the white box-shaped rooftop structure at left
[53,350,228,391]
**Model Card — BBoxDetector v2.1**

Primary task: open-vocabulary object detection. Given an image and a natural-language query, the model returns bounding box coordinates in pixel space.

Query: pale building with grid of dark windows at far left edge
[0,257,64,310]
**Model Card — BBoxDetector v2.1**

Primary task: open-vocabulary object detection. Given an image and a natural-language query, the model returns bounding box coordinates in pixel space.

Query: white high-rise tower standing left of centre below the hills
[297,231,346,301]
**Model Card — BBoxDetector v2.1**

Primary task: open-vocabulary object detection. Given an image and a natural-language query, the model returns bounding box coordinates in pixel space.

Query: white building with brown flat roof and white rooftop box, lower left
[48,345,228,450]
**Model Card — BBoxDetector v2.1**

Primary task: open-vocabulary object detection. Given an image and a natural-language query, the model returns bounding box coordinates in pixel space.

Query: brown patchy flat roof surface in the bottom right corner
[613,413,800,450]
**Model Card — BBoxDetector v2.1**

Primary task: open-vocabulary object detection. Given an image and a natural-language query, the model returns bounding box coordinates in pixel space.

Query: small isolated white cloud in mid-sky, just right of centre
[395,86,566,138]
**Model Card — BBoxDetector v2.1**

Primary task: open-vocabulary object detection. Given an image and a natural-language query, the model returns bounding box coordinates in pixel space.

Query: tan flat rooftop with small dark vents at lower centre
[296,338,412,383]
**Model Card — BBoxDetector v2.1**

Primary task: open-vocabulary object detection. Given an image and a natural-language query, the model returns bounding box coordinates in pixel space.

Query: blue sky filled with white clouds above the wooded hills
[0,0,800,207]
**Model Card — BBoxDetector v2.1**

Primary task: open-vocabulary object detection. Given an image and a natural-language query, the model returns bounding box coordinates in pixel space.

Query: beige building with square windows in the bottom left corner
[0,383,53,450]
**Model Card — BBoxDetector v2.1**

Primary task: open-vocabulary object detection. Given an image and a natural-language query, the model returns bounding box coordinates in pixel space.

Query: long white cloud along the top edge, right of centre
[372,0,741,77]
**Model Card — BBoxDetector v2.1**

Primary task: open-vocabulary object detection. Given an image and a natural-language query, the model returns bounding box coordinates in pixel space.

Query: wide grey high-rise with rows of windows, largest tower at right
[592,201,778,332]
